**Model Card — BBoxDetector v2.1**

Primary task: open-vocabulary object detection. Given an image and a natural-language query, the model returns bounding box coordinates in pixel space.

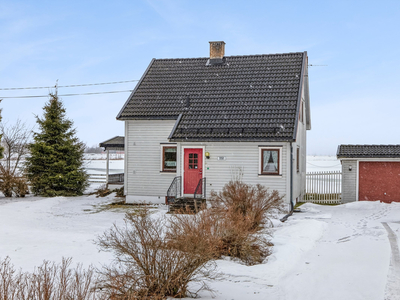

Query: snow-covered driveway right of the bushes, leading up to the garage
[204,202,400,300]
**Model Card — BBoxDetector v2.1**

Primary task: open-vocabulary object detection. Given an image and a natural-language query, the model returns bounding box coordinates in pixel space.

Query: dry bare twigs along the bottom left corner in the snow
[0,258,99,300]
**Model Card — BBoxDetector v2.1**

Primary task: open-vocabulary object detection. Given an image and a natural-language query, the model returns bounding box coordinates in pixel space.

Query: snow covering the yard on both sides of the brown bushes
[0,196,400,300]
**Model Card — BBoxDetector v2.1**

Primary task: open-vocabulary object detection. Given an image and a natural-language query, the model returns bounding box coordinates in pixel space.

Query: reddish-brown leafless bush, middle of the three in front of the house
[168,205,272,265]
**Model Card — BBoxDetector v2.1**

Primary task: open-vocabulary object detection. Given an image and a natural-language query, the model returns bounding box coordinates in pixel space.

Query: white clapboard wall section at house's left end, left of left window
[125,120,177,198]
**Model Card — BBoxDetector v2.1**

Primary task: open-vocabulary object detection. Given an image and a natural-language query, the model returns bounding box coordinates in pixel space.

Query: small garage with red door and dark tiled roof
[337,145,400,203]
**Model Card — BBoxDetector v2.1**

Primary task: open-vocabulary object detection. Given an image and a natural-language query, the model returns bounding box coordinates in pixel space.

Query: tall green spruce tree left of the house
[26,93,88,197]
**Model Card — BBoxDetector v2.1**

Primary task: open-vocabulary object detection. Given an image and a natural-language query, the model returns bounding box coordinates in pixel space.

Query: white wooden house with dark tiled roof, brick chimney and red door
[117,42,311,209]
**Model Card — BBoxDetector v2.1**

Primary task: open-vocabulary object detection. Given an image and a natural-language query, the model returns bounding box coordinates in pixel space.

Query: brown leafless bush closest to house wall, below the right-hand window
[209,180,283,230]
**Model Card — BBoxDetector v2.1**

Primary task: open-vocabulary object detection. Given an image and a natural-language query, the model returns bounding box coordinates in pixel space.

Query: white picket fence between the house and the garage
[302,171,342,204]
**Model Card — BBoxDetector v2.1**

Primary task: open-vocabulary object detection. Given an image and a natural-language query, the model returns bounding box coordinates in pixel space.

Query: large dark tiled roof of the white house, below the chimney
[117,52,307,141]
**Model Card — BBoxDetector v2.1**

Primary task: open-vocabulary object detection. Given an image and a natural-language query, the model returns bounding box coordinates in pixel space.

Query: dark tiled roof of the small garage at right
[337,145,400,158]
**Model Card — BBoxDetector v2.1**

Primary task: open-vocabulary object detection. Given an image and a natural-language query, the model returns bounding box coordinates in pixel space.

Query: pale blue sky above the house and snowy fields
[0,0,400,155]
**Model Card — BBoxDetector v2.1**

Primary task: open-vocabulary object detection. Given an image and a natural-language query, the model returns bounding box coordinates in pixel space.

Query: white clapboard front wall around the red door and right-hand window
[180,142,288,200]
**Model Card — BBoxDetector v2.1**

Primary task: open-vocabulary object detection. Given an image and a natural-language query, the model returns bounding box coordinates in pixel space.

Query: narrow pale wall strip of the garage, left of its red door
[342,160,358,203]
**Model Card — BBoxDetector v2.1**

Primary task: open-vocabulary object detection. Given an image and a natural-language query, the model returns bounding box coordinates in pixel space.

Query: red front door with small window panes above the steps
[183,148,203,194]
